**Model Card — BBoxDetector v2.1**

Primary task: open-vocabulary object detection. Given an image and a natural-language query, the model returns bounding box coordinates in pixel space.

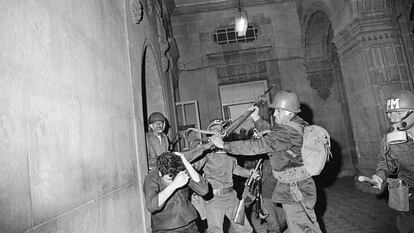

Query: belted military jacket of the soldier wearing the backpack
[224,116,316,204]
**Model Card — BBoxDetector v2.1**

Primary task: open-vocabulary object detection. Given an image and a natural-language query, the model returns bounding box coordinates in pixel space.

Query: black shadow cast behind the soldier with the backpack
[298,104,342,232]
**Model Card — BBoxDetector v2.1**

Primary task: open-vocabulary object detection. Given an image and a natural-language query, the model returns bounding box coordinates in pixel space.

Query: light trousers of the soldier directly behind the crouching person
[206,191,253,233]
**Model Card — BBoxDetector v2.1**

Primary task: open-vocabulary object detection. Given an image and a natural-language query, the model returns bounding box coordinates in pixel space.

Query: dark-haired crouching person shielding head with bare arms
[144,152,208,233]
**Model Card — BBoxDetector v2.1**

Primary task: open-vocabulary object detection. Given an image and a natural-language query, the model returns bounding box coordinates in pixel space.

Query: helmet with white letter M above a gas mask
[385,90,414,113]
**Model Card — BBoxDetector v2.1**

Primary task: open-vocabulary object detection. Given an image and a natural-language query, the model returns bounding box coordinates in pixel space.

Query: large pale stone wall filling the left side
[0,0,178,233]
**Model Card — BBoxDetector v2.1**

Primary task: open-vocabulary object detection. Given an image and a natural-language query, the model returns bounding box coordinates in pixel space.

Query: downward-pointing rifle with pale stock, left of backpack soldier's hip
[233,159,263,225]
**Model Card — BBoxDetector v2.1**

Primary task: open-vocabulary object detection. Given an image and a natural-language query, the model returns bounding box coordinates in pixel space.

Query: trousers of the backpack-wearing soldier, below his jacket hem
[282,203,322,233]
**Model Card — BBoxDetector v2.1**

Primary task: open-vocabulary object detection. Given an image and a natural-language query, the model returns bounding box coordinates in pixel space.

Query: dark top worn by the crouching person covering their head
[144,168,208,231]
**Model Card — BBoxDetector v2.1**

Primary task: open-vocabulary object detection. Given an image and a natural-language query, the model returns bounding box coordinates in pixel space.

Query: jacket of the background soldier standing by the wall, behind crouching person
[145,130,170,170]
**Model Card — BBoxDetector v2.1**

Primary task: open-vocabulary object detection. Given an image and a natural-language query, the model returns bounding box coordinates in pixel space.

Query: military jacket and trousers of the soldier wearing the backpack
[223,116,320,233]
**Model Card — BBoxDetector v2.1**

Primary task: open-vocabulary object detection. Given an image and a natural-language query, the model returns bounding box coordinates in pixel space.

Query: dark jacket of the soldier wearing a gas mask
[376,138,414,187]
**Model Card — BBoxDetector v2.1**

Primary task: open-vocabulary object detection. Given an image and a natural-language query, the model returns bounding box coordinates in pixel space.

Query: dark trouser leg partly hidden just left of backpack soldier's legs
[263,198,286,233]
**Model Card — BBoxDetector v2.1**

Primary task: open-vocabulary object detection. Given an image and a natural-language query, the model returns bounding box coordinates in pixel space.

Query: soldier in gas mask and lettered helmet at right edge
[372,91,414,233]
